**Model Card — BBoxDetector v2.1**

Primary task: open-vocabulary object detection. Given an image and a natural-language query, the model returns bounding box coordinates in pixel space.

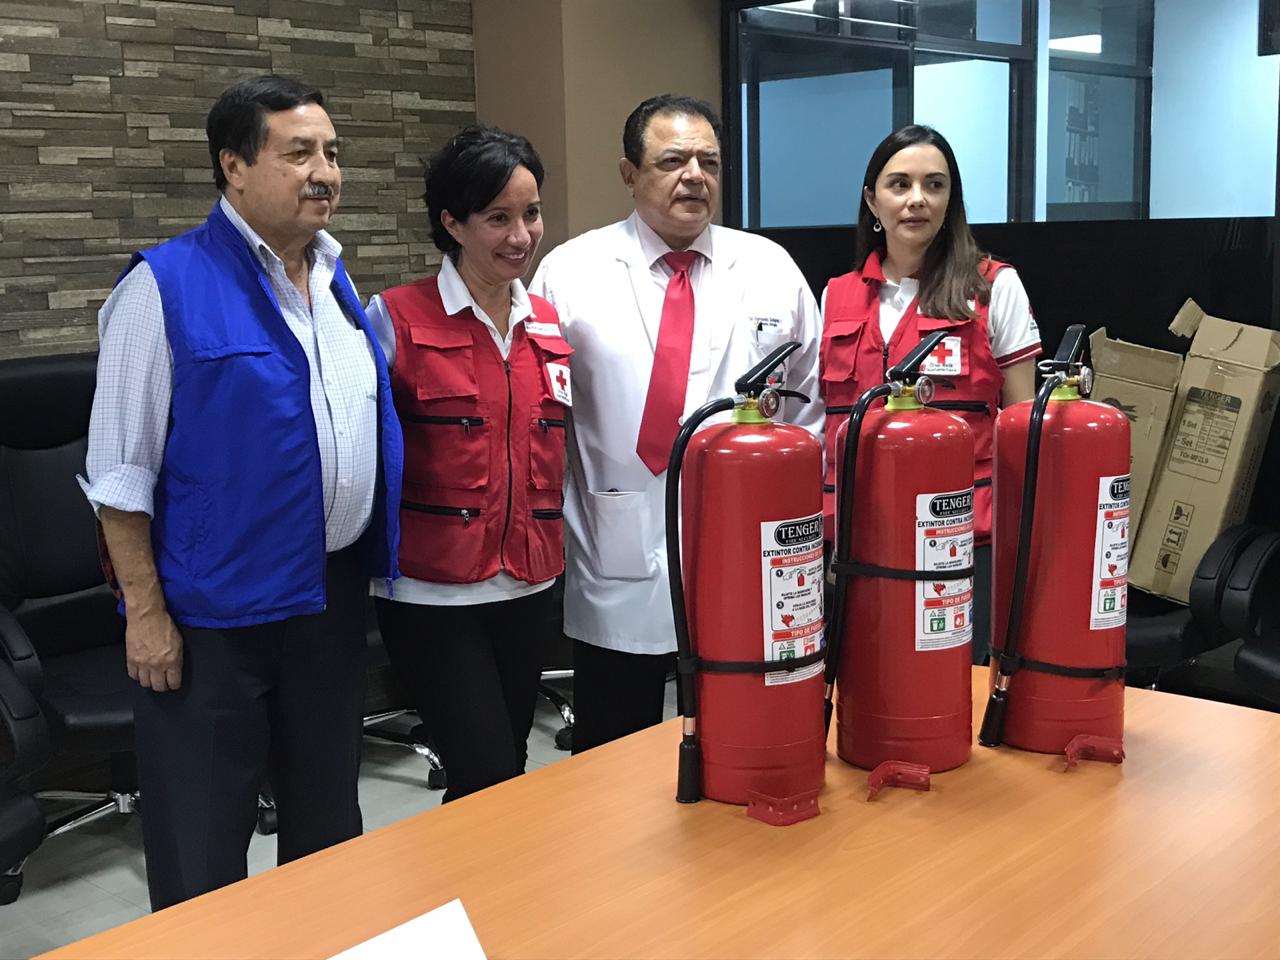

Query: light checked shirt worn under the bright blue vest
[81,197,378,553]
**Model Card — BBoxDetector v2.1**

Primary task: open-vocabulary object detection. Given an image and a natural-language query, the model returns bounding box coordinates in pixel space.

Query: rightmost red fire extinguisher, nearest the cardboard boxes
[978,324,1132,763]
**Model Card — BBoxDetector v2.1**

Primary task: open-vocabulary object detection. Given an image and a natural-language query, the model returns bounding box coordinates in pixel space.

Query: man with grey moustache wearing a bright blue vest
[84,77,402,910]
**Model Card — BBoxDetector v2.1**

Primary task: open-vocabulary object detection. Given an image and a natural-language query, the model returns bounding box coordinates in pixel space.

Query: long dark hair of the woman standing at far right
[854,124,991,320]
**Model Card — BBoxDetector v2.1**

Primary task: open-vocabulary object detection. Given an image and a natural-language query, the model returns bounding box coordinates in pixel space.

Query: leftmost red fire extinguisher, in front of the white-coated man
[667,343,826,824]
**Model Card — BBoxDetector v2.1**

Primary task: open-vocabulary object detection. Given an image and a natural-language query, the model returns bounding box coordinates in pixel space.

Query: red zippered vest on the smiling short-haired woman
[383,276,572,584]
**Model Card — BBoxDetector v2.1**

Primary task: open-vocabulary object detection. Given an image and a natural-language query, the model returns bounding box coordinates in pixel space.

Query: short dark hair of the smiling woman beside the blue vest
[422,125,543,260]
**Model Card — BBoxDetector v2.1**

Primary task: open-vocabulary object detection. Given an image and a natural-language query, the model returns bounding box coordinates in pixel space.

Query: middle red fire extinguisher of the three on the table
[827,332,974,776]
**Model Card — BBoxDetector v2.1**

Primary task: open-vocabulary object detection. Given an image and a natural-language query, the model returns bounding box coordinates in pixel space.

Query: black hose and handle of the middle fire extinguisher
[822,330,946,732]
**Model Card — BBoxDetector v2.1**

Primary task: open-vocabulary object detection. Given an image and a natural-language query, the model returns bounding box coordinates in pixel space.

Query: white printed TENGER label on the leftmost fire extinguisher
[760,513,822,686]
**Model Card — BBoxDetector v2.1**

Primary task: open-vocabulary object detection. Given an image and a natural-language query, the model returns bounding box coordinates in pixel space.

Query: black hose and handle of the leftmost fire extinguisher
[666,340,808,804]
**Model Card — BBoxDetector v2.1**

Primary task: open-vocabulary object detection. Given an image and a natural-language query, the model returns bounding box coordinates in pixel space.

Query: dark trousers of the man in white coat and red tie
[573,640,676,754]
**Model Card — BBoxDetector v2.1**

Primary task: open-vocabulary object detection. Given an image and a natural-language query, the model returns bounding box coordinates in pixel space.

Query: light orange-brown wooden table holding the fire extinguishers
[46,671,1280,960]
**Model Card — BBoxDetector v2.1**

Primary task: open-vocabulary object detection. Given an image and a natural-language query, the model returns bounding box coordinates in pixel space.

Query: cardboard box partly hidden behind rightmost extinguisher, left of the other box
[1089,326,1183,530]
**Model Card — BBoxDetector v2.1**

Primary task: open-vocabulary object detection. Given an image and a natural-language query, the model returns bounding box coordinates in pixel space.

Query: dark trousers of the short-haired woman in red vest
[378,589,553,803]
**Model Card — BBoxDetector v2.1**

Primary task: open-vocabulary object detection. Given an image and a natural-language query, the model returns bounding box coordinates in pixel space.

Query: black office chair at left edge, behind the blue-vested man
[0,355,138,836]
